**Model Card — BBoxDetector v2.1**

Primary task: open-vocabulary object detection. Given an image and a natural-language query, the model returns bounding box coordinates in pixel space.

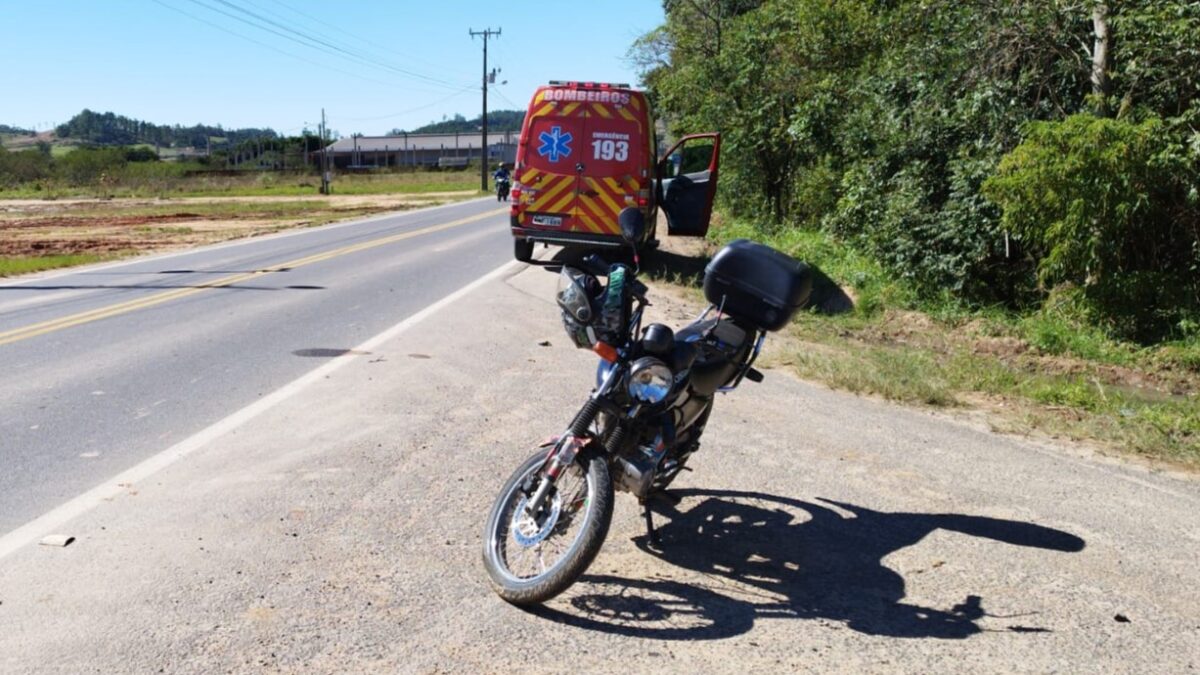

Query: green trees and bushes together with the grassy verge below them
[630,0,1200,466]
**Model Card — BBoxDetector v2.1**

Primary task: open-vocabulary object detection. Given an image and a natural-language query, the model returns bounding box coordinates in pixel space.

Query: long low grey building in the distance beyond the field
[314,131,520,169]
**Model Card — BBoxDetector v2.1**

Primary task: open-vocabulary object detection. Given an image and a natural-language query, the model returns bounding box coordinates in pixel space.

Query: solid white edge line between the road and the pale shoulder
[0,253,521,558]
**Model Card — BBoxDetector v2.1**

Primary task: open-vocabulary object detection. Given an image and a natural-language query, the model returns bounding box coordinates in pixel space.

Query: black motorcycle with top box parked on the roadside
[484,208,812,605]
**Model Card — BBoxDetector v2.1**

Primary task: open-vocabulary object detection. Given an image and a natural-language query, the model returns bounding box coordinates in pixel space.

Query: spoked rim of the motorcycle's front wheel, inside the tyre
[491,462,596,584]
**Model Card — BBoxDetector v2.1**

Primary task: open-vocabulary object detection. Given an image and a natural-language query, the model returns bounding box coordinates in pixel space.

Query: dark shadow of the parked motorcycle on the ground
[534,490,1085,640]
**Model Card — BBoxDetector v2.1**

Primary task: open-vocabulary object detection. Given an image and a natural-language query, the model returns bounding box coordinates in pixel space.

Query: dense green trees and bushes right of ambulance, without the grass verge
[631,0,1200,345]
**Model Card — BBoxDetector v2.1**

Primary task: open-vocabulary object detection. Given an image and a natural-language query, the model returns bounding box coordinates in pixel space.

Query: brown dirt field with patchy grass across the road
[0,191,475,258]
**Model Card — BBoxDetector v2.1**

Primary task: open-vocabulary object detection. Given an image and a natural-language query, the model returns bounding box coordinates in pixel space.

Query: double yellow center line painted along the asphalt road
[0,209,506,345]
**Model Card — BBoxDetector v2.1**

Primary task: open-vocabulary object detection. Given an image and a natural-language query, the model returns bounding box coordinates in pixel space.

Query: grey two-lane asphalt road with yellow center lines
[0,198,511,534]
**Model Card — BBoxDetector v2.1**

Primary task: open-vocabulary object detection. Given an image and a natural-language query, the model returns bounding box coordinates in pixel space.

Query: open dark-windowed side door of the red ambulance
[656,133,721,237]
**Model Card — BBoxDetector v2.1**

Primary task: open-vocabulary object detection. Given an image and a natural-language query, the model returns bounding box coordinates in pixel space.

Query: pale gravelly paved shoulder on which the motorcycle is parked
[0,246,1200,674]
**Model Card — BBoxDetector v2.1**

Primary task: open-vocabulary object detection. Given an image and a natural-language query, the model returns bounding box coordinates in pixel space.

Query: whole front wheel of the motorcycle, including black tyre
[484,450,613,605]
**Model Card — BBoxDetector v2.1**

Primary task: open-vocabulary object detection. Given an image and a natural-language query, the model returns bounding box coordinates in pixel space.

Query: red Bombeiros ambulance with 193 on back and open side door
[510,82,721,262]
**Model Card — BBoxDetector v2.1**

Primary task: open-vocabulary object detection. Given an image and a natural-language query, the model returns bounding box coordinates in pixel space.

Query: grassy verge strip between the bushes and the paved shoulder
[770,317,1200,467]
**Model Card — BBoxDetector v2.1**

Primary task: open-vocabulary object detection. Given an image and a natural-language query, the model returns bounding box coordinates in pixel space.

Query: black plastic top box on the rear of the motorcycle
[704,239,812,330]
